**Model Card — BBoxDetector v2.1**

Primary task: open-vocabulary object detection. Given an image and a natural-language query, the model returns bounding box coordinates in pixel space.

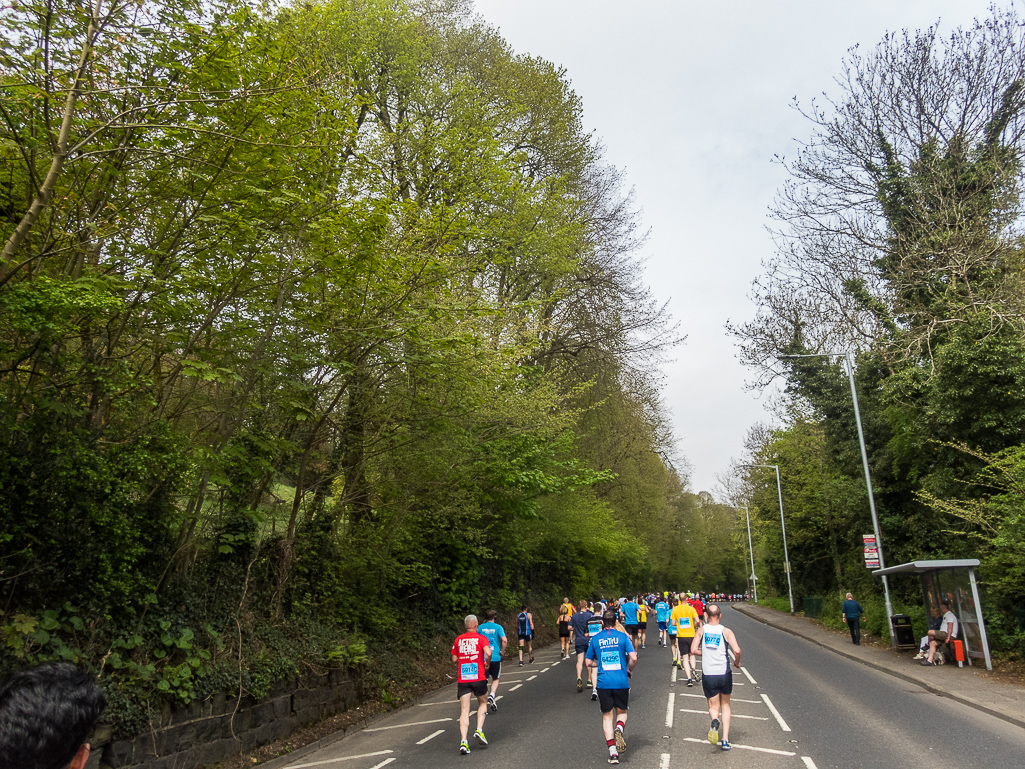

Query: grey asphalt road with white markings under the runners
[272,610,1025,769]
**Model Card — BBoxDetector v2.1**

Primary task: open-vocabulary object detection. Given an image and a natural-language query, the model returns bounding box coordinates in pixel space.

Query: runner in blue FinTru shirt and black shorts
[587,611,638,764]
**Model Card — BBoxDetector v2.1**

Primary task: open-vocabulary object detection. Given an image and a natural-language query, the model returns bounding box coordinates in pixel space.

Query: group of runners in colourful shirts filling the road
[452,593,744,764]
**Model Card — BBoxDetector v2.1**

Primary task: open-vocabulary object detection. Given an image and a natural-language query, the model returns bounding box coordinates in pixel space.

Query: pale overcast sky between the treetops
[476,0,1008,491]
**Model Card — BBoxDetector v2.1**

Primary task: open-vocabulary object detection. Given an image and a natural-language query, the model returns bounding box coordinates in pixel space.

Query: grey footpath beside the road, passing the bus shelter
[733,604,1025,729]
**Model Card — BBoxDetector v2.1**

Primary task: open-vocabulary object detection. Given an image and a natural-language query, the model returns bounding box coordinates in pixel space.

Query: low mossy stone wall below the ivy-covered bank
[86,671,357,769]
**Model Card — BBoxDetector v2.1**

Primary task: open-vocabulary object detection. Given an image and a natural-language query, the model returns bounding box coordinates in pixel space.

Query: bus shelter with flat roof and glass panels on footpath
[872,558,993,671]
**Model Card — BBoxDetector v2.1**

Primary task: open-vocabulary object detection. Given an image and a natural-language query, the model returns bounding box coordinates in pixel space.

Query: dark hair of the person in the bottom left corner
[0,662,107,769]
